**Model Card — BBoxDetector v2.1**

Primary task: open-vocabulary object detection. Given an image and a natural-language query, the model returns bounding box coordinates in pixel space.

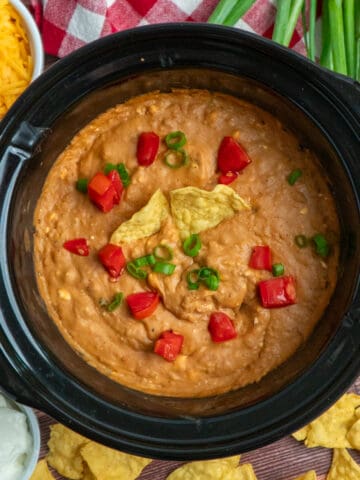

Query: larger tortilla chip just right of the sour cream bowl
[47,423,90,480]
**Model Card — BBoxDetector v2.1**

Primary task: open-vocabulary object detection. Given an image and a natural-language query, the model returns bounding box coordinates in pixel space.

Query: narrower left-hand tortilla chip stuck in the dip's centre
[110,190,170,245]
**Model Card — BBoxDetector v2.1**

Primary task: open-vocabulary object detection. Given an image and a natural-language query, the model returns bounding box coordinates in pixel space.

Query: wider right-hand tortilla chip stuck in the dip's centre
[170,184,250,239]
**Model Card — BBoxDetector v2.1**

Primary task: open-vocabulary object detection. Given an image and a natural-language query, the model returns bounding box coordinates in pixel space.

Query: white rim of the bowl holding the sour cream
[0,389,41,480]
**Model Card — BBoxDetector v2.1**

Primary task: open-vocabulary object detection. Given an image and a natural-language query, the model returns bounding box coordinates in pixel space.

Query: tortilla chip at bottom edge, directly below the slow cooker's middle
[166,455,242,480]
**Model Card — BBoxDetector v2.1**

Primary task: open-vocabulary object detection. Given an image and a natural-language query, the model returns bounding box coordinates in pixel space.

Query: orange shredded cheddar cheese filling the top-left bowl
[0,0,33,120]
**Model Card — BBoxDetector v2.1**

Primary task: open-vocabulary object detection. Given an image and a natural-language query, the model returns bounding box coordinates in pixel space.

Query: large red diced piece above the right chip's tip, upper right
[217,137,251,173]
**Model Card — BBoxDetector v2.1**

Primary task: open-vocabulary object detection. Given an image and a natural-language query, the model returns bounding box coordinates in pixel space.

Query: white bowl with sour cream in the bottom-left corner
[0,391,40,480]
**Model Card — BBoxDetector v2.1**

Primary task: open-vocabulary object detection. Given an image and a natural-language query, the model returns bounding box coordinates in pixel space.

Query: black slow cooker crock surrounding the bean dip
[0,24,360,459]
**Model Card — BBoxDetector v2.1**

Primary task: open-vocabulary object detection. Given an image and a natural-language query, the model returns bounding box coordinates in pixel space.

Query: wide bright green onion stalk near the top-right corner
[328,0,347,75]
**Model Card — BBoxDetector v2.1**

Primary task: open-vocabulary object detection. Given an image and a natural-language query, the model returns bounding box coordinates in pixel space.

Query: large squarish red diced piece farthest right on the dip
[259,275,296,308]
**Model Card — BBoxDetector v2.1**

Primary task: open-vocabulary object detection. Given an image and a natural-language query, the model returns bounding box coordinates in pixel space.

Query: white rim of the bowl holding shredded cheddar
[9,0,44,80]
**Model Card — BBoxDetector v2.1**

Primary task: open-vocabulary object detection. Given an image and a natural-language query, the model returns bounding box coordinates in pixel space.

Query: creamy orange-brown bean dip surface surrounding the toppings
[34,90,339,397]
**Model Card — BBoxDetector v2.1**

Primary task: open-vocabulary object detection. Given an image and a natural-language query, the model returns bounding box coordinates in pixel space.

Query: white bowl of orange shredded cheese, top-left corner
[0,0,44,120]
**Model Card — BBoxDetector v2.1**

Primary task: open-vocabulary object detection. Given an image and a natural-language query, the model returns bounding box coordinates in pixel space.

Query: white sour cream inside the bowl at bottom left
[0,395,32,480]
